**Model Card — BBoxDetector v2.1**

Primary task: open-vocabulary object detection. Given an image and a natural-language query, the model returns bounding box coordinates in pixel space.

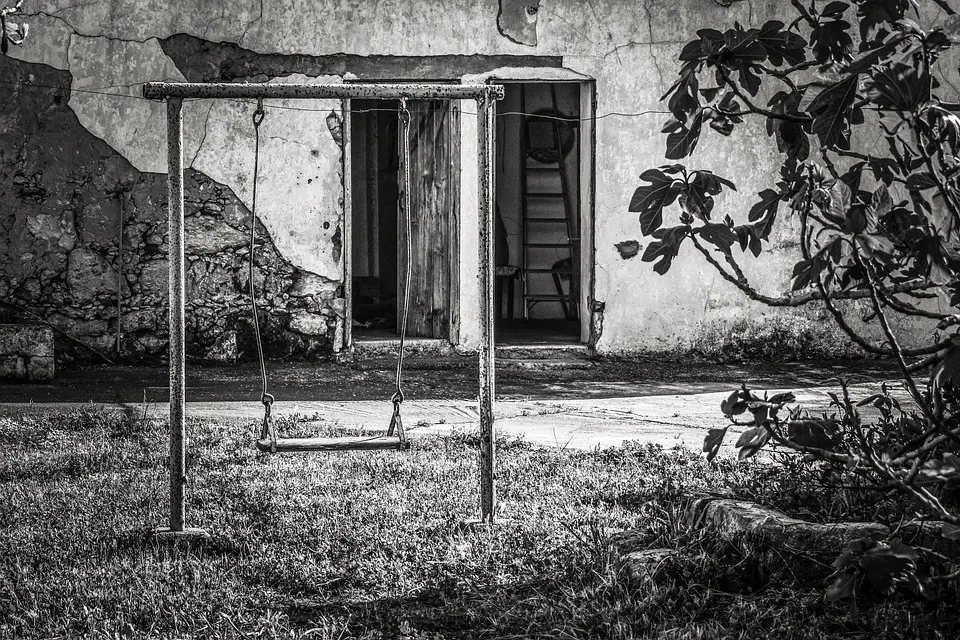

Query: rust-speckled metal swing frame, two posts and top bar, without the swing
[143,82,504,539]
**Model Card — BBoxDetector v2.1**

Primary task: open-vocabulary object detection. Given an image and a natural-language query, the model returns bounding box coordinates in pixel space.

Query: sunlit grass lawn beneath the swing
[0,412,958,639]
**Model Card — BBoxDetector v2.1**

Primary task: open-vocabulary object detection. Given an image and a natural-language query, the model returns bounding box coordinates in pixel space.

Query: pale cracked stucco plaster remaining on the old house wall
[0,0,952,360]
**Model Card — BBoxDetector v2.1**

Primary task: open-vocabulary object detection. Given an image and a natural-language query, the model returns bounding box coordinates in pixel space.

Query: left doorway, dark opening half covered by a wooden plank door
[350,100,460,341]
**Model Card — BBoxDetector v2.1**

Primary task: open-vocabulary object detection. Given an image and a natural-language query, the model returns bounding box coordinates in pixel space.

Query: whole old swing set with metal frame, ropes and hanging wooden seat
[143,82,504,539]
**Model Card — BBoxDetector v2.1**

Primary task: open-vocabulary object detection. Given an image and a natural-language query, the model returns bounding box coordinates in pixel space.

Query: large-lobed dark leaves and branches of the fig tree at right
[630,0,960,599]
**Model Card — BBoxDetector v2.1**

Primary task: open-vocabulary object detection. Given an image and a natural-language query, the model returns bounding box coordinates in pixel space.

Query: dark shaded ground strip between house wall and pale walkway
[0,356,897,403]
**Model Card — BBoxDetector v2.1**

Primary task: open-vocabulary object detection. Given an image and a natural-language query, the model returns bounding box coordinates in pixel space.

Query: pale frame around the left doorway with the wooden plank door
[344,86,462,351]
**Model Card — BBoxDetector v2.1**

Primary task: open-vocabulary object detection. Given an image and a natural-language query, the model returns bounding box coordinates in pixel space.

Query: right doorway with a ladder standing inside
[495,82,587,344]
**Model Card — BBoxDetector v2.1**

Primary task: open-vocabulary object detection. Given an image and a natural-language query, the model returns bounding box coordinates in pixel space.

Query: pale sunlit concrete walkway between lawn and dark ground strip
[0,382,904,449]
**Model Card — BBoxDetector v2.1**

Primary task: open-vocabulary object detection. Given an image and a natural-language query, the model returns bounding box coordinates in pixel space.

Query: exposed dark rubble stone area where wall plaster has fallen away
[0,56,343,361]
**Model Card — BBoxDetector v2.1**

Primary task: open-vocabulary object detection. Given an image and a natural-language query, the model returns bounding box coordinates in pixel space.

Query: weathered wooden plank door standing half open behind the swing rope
[397,100,460,338]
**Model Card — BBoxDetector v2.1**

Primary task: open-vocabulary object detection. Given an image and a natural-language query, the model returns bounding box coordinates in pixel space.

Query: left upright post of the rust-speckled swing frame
[167,98,187,532]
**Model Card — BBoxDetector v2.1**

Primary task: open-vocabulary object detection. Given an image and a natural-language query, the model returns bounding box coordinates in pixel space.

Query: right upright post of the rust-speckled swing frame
[477,94,497,522]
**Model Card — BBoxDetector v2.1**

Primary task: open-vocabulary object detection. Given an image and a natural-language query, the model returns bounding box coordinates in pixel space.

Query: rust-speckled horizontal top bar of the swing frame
[143,82,503,100]
